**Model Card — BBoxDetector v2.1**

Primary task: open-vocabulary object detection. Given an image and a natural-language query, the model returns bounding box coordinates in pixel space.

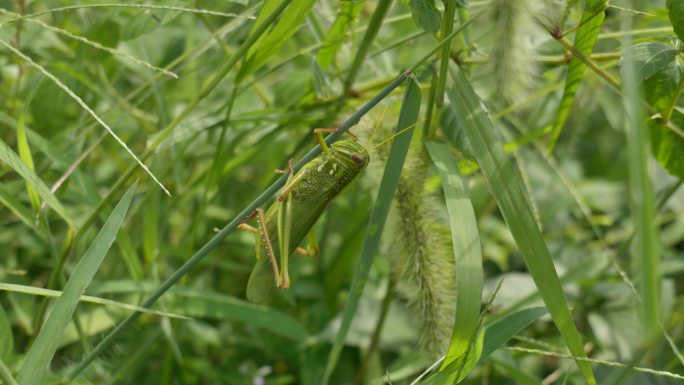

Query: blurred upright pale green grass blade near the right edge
[621,3,661,339]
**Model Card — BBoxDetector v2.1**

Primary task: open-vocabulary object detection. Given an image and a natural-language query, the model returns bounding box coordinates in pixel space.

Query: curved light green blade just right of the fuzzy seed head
[426,142,484,382]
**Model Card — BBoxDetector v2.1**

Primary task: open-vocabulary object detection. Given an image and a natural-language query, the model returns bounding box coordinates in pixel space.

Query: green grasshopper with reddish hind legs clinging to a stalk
[240,128,369,302]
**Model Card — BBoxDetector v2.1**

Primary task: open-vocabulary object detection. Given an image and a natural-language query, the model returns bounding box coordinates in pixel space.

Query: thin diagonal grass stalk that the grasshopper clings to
[67,74,407,381]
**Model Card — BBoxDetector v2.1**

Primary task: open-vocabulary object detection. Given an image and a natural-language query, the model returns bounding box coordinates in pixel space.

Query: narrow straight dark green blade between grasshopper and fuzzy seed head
[322,78,420,385]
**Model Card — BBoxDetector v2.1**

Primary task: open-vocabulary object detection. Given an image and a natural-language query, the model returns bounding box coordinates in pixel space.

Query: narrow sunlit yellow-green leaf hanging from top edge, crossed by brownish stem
[549,0,608,151]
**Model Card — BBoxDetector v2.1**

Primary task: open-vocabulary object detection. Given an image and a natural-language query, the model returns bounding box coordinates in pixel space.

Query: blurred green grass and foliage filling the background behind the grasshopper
[0,0,684,384]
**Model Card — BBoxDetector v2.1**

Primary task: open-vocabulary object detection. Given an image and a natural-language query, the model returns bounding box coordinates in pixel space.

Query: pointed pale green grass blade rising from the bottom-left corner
[17,185,135,385]
